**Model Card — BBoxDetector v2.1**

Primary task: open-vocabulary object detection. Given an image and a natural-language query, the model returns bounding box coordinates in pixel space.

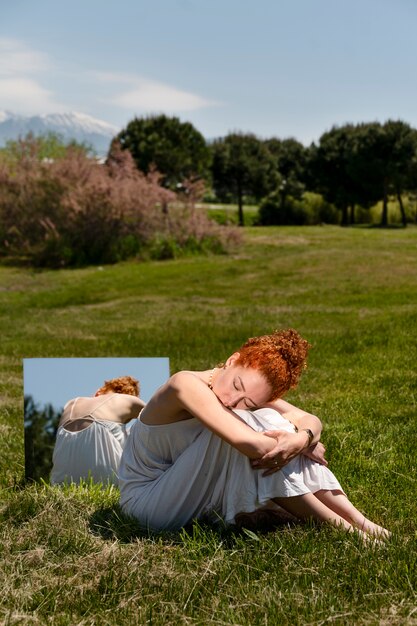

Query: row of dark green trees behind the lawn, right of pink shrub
[109,115,417,226]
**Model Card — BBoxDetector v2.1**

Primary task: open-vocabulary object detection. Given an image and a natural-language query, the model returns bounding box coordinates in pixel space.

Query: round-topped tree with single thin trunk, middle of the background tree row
[211,133,280,226]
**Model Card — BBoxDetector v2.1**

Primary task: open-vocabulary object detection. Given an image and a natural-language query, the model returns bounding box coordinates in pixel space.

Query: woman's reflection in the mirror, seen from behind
[50,376,145,485]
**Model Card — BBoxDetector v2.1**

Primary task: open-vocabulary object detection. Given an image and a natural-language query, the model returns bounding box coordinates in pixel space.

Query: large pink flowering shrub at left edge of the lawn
[0,137,239,267]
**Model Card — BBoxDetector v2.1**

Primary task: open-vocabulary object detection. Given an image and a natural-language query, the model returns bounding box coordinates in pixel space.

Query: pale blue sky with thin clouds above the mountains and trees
[0,0,417,145]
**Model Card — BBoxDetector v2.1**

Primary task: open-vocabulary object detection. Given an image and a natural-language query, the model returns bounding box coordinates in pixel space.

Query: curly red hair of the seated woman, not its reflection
[236,328,311,401]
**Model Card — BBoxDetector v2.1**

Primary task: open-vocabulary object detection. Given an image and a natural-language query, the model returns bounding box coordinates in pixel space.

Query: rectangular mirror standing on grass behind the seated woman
[23,357,170,484]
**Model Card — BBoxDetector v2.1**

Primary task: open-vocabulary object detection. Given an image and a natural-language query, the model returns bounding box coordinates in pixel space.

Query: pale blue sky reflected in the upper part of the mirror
[23,357,170,409]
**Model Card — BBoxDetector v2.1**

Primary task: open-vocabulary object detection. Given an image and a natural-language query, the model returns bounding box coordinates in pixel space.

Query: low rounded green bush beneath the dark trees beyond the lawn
[258,191,340,226]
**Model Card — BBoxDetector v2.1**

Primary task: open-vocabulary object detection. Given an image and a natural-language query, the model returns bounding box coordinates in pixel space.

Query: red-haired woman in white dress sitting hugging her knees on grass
[119,329,386,536]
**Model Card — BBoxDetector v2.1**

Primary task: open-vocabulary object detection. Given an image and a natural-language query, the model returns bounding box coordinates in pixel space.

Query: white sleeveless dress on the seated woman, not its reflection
[119,409,343,530]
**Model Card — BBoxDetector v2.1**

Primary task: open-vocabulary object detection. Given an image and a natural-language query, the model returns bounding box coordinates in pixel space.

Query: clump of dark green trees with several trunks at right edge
[310,120,417,226]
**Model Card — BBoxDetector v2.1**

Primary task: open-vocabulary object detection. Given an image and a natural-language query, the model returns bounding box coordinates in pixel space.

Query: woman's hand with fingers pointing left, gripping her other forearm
[251,430,308,476]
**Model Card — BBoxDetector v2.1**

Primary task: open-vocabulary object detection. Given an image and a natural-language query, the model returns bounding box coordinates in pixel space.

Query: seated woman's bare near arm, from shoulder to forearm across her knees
[141,372,275,459]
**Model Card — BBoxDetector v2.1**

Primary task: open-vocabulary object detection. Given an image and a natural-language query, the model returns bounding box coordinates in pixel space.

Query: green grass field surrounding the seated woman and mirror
[0,227,417,626]
